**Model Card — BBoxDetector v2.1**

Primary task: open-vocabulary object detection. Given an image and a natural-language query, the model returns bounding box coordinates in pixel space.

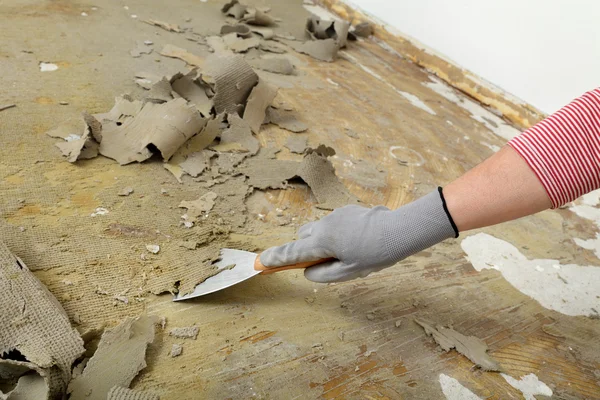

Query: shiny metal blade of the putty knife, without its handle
[173,249,260,301]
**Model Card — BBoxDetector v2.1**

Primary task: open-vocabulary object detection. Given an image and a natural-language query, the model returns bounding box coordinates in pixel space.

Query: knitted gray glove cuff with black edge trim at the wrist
[382,188,458,262]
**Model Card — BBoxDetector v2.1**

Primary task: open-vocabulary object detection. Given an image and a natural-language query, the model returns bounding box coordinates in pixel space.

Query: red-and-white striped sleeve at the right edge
[508,88,600,208]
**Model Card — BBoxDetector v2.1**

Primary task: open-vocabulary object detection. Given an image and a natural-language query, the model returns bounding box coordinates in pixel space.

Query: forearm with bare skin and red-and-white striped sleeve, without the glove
[444,89,600,232]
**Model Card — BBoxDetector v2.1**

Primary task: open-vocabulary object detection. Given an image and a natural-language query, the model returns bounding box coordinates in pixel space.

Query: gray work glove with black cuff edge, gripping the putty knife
[260,188,458,283]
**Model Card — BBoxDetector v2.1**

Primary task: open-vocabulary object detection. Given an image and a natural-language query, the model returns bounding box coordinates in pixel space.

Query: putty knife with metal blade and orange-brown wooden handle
[173,249,331,301]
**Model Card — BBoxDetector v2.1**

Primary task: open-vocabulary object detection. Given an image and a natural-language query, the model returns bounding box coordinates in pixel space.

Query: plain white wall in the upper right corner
[348,0,600,113]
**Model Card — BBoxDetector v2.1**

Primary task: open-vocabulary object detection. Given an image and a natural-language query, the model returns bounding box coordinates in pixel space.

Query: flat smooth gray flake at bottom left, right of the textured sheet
[68,316,155,400]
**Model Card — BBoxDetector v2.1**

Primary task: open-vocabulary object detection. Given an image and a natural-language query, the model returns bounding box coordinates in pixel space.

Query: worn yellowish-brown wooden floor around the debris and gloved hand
[0,0,600,399]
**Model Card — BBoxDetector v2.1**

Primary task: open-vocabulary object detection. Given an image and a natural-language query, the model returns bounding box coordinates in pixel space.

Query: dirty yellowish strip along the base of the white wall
[317,0,546,129]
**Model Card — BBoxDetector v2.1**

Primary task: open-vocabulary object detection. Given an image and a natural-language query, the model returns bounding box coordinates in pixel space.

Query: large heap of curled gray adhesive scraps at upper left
[47,55,277,166]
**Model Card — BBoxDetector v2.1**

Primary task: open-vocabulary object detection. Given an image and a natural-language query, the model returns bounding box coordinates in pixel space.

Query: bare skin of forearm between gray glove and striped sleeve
[444,146,552,232]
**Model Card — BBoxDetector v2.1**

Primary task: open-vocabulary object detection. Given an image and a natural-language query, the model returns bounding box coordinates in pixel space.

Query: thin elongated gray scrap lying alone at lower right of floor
[415,319,500,371]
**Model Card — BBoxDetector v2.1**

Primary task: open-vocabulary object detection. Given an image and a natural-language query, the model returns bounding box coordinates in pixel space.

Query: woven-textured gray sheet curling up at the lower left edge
[0,242,85,398]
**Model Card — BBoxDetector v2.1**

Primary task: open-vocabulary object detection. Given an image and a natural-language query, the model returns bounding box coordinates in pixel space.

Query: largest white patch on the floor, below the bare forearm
[460,233,600,316]
